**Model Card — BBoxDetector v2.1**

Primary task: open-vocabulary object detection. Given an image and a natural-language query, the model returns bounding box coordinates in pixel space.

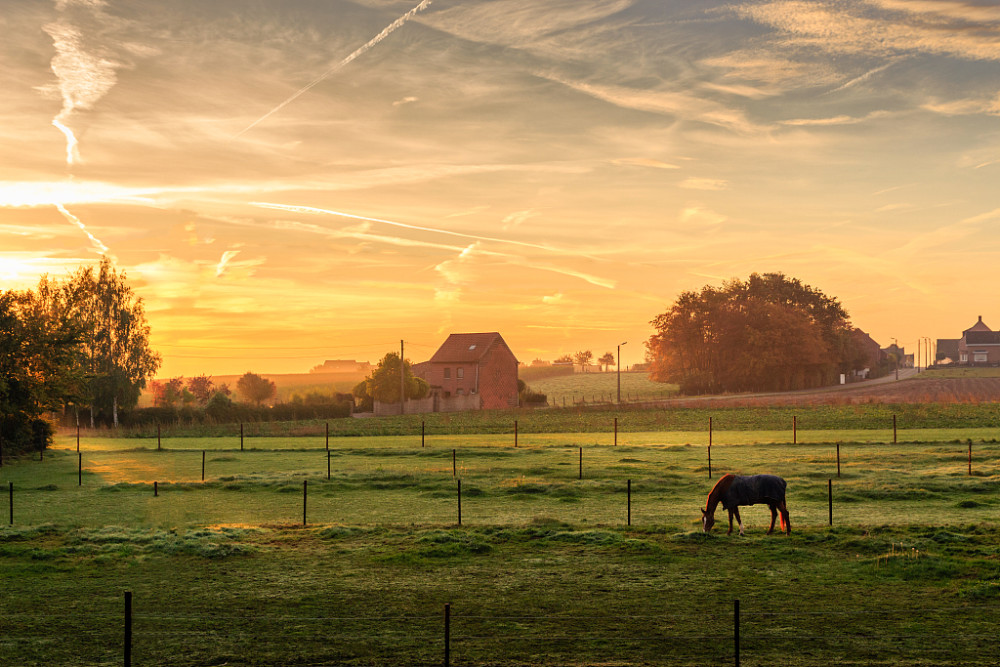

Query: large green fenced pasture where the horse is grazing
[0,429,1000,665]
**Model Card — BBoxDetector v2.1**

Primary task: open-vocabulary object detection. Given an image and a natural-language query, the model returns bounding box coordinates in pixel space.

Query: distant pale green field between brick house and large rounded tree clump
[528,372,677,407]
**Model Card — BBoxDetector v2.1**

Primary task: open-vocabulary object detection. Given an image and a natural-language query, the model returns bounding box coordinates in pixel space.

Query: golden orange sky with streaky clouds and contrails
[0,0,1000,377]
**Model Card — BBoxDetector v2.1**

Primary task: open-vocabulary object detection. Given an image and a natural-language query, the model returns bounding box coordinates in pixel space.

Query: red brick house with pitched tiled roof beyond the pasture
[413,331,518,412]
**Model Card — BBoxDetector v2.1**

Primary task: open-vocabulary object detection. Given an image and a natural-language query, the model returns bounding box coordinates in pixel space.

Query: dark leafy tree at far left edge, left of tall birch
[0,288,84,456]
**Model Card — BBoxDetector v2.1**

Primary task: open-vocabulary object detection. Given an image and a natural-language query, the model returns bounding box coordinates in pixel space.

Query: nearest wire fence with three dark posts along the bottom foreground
[0,592,1000,667]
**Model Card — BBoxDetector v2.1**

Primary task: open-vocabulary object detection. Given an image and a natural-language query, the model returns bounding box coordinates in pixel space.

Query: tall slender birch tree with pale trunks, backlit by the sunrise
[61,257,162,426]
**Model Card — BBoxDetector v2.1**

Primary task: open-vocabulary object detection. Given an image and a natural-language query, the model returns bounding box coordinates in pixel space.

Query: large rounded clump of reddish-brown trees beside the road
[647,273,863,394]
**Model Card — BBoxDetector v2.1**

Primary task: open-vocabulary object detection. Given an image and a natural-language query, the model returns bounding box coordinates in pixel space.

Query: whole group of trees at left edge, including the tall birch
[0,257,161,452]
